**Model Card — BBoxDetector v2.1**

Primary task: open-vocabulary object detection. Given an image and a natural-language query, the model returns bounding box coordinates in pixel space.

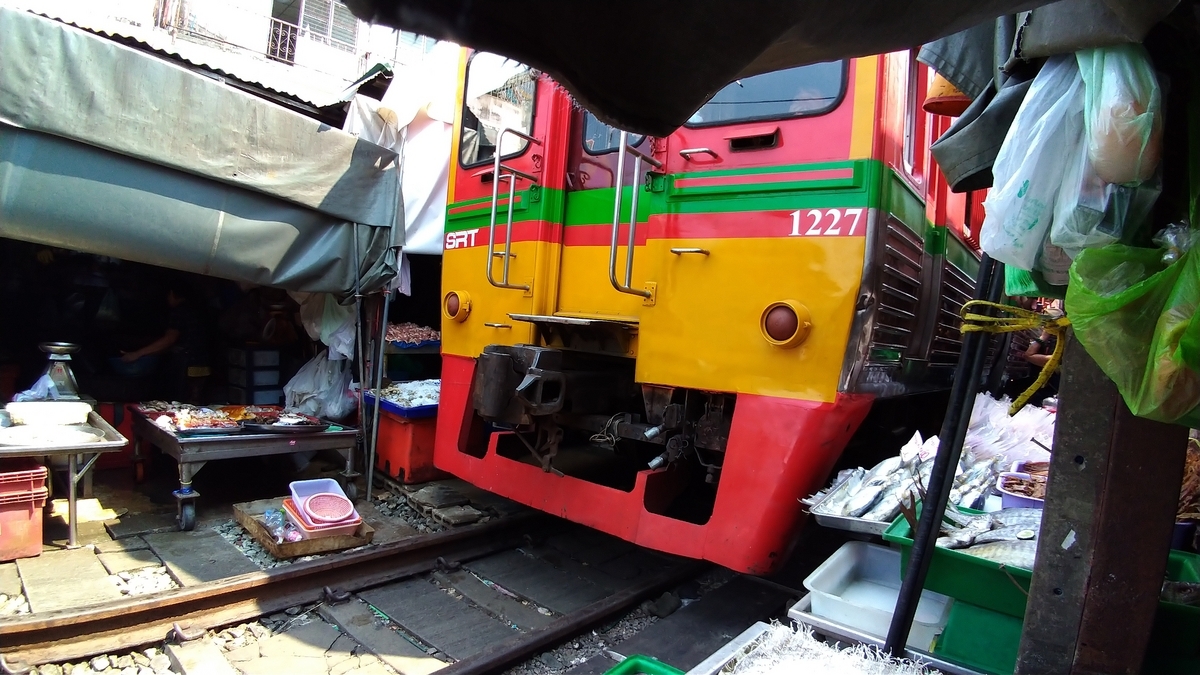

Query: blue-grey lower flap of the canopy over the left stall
[0,124,398,298]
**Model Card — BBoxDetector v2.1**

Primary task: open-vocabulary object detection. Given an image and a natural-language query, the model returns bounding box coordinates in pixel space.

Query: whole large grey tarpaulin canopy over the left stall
[0,7,404,297]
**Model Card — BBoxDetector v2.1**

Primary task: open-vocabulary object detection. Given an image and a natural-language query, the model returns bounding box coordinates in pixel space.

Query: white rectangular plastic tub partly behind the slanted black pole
[804,542,952,651]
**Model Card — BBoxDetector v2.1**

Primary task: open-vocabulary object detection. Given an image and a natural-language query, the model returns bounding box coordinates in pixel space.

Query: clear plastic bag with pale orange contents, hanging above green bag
[1075,44,1163,184]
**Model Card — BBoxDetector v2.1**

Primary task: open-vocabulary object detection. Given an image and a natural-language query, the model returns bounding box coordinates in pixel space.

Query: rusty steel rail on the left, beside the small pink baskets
[0,512,546,664]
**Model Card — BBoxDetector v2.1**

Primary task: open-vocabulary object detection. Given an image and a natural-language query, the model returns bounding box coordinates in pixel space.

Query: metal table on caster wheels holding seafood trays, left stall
[131,410,358,530]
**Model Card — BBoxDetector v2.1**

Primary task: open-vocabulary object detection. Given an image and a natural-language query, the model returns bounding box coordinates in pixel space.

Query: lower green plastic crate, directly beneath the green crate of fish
[934,601,1022,675]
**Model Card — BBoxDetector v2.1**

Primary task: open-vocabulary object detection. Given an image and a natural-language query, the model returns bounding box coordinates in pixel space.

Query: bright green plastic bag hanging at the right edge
[1067,237,1200,426]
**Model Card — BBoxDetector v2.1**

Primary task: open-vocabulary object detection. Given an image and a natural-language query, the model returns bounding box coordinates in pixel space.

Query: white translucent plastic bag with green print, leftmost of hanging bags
[979,56,1084,270]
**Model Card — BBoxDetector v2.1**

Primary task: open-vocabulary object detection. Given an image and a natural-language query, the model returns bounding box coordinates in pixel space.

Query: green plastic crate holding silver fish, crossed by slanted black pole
[883,509,1033,619]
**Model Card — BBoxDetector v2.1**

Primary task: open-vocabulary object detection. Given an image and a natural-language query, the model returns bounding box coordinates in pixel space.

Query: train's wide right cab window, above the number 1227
[685,61,846,127]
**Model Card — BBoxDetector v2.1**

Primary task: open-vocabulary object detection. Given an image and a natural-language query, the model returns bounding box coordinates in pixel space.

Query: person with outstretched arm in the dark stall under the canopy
[121,281,211,404]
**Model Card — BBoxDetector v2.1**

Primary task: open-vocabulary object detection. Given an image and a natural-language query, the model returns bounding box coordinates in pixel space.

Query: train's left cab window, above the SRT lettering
[458,52,538,167]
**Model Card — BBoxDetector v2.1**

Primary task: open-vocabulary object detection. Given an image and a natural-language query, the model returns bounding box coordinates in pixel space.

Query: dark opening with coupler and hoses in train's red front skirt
[472,345,736,522]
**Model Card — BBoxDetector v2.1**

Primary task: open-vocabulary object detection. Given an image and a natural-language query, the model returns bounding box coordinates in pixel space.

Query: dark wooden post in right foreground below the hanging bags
[1016,336,1188,675]
